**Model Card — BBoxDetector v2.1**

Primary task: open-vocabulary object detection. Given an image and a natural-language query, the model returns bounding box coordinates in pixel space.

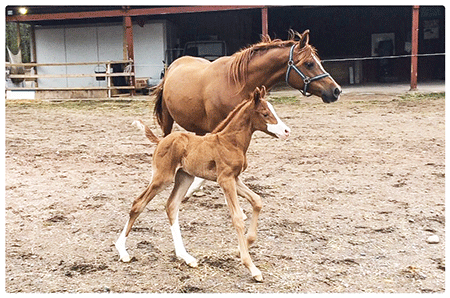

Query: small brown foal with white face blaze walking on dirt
[116,86,290,281]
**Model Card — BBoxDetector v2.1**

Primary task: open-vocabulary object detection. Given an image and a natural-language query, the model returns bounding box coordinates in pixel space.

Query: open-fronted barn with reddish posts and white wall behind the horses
[6,6,445,96]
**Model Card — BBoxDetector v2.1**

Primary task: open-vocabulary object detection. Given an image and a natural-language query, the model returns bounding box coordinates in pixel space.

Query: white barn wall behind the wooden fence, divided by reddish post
[35,22,166,87]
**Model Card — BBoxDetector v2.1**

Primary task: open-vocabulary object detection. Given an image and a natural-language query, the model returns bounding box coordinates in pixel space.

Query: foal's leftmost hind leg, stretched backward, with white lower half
[115,173,172,262]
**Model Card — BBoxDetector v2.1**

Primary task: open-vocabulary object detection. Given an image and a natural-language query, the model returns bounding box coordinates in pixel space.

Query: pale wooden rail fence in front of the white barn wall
[5,60,136,97]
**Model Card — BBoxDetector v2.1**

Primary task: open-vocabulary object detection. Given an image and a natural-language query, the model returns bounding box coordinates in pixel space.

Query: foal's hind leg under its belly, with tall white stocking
[166,169,197,267]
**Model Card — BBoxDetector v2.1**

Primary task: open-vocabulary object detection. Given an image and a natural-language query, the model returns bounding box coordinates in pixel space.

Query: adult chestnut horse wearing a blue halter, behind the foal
[153,30,341,136]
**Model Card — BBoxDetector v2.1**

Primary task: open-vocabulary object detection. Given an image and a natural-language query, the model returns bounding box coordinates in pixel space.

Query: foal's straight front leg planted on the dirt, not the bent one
[217,177,262,281]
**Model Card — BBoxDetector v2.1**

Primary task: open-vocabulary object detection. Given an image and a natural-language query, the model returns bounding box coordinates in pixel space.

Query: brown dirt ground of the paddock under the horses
[5,89,445,293]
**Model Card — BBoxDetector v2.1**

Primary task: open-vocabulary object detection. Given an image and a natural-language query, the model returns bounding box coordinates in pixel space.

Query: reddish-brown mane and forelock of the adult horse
[229,30,316,88]
